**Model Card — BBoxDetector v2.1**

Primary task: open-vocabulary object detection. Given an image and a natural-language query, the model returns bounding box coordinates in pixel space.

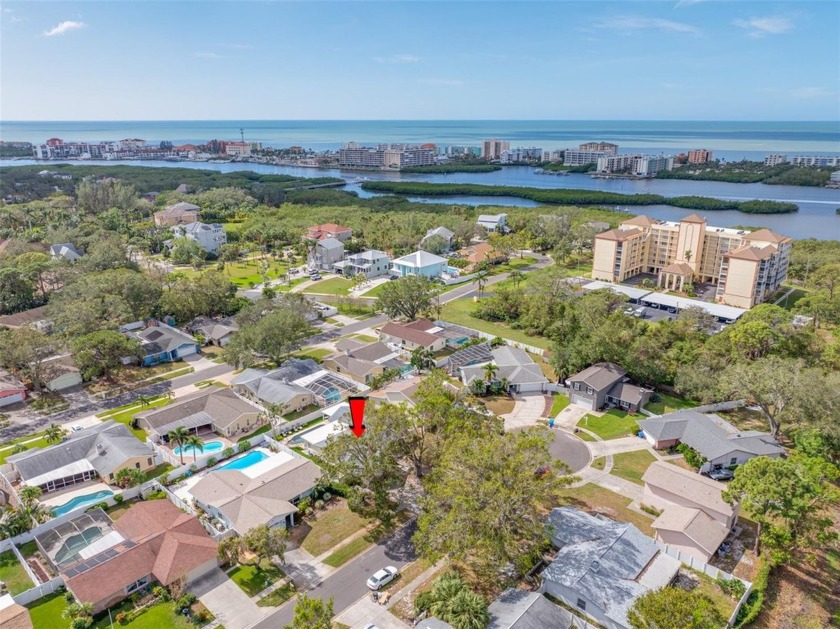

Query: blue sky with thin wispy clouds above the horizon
[0,0,840,120]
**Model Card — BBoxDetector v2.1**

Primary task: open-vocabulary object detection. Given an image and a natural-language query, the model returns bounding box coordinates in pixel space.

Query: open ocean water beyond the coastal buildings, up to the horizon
[0,120,840,160]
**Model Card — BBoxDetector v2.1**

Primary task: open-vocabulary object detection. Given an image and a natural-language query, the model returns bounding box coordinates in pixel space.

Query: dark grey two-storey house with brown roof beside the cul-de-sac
[566,363,653,413]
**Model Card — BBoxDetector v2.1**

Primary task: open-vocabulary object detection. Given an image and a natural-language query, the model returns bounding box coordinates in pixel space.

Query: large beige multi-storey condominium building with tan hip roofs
[592,214,791,308]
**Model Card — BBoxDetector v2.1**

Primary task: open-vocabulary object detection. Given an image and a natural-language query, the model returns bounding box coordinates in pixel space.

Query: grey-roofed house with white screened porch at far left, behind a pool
[6,420,156,493]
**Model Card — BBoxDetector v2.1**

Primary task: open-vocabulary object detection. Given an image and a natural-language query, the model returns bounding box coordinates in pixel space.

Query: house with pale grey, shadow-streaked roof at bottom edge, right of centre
[541,507,680,629]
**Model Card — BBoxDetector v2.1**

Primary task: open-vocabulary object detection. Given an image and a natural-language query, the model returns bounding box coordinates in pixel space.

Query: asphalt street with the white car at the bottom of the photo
[249,522,417,629]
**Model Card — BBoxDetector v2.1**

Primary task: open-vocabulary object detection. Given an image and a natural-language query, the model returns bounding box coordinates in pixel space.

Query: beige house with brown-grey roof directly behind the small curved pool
[134,389,264,441]
